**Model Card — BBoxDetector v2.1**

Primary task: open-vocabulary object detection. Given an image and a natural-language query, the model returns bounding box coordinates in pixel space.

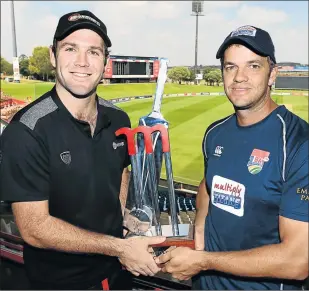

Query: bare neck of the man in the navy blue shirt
[236,96,278,126]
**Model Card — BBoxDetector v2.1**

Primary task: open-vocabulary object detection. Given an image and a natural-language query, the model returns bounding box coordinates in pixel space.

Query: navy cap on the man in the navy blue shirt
[216,25,276,63]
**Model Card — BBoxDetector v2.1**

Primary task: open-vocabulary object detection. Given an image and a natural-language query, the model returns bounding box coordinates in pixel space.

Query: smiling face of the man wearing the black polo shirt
[50,29,105,95]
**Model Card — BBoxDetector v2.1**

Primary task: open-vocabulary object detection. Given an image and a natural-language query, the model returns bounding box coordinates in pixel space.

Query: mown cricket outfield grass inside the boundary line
[117,95,308,185]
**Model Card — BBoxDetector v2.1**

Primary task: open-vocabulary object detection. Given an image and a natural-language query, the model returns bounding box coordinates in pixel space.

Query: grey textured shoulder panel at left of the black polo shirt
[19,97,58,130]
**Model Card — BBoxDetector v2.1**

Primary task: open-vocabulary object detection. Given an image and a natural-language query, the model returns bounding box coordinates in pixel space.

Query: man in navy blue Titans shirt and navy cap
[157,26,309,290]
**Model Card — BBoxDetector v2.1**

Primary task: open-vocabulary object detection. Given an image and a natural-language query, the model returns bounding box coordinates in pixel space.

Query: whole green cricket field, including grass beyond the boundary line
[1,82,308,185]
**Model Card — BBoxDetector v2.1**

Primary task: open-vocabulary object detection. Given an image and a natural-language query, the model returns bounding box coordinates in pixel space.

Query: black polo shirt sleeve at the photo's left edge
[0,122,49,202]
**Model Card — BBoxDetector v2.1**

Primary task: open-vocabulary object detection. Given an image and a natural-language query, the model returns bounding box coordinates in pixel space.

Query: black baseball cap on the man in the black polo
[54,10,112,47]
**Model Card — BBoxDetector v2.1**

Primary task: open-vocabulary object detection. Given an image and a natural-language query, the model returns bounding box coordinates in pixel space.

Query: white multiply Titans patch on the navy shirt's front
[211,175,246,217]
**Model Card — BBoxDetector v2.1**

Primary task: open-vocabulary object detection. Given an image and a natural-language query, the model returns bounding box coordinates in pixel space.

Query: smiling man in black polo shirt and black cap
[0,11,164,289]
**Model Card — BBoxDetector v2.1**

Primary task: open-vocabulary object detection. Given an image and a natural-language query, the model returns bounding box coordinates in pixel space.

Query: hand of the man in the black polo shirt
[119,236,166,276]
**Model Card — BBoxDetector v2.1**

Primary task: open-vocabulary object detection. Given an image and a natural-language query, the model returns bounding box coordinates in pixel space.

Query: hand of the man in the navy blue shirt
[155,247,204,280]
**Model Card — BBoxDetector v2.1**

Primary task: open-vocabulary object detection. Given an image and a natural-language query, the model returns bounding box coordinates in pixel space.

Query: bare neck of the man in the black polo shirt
[56,82,97,121]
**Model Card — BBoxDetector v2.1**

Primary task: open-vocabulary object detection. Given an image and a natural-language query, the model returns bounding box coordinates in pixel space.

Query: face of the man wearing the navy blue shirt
[223,44,277,109]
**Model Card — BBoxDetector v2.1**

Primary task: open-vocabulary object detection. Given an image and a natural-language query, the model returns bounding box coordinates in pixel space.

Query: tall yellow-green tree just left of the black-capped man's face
[29,46,53,80]
